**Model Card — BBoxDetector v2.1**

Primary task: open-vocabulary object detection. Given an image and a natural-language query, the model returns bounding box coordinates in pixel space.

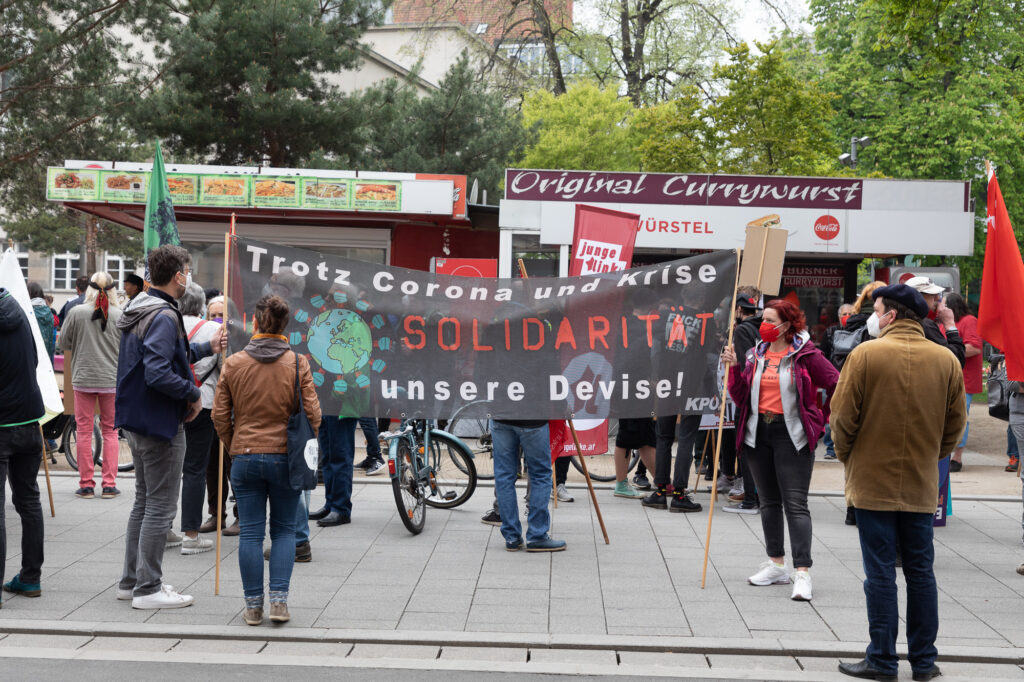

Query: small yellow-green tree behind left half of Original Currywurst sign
[518,83,639,171]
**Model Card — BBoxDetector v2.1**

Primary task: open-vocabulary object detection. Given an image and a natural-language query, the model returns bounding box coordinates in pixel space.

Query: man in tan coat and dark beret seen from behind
[831,285,967,680]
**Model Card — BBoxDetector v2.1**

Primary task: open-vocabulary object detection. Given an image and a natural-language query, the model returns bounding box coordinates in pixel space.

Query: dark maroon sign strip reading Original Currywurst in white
[505,168,863,210]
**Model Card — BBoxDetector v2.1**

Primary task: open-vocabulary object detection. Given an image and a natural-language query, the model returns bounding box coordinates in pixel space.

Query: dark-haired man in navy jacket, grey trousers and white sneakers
[115,245,227,608]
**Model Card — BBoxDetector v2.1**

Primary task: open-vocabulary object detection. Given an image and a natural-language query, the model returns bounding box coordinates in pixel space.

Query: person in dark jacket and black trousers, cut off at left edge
[0,289,45,597]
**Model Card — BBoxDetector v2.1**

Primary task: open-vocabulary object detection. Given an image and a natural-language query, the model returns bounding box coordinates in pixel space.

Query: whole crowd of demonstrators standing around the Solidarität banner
[0,246,999,679]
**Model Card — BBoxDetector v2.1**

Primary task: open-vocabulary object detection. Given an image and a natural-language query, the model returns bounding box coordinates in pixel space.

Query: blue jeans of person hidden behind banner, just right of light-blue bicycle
[490,421,551,543]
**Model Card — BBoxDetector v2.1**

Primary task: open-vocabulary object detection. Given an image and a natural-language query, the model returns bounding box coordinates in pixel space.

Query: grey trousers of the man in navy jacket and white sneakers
[118,426,185,597]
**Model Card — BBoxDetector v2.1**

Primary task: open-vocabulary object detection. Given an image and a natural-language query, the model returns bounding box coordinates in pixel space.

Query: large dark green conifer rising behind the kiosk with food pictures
[135,0,387,166]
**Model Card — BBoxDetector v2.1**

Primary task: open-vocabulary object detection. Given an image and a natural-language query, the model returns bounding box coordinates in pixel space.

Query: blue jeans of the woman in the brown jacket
[231,455,299,605]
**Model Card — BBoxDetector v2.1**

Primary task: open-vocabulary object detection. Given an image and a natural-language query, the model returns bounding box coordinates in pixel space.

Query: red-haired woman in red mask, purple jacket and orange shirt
[722,299,839,601]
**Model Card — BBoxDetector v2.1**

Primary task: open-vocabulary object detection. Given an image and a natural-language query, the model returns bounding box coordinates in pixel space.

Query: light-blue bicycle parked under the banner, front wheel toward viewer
[381,420,477,535]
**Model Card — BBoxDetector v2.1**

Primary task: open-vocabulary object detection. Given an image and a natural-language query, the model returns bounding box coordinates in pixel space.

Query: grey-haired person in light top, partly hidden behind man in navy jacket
[178,282,230,555]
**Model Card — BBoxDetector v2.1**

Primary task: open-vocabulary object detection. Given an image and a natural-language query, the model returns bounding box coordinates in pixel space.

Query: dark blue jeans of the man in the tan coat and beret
[857,509,939,675]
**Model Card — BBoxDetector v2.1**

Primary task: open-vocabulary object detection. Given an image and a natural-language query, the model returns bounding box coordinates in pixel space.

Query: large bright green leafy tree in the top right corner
[810,0,1024,282]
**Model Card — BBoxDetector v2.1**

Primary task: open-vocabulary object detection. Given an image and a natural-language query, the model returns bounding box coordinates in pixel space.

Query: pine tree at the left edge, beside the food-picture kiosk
[0,0,151,260]
